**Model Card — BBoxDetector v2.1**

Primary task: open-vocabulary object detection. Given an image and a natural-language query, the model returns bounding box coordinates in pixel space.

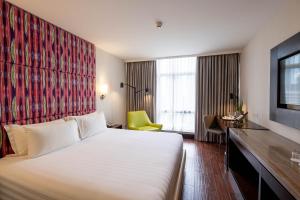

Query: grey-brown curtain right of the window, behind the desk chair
[195,54,240,142]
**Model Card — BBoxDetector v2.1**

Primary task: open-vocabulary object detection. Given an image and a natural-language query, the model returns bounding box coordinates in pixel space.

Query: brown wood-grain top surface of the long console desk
[230,128,300,199]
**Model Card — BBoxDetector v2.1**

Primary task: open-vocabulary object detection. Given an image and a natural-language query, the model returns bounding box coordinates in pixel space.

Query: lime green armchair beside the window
[127,110,162,131]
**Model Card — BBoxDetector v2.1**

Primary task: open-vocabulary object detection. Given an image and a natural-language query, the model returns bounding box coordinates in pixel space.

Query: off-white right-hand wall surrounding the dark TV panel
[241,0,300,143]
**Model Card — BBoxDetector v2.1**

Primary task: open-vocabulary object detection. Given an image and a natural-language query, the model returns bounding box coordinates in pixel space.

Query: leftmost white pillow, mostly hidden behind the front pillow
[4,119,64,156]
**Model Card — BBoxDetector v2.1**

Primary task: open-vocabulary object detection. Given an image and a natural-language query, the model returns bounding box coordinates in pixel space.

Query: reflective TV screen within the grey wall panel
[279,53,300,110]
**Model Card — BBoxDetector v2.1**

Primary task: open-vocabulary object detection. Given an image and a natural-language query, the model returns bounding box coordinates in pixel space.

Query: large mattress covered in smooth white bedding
[0,129,183,200]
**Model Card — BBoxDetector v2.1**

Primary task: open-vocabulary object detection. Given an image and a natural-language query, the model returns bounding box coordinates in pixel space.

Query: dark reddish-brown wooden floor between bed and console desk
[182,139,236,200]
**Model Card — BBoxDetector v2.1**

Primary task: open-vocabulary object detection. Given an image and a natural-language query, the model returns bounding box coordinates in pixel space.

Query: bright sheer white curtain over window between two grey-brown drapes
[156,57,197,132]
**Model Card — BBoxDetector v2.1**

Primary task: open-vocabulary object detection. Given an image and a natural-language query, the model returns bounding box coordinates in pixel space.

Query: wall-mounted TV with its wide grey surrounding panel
[270,32,300,129]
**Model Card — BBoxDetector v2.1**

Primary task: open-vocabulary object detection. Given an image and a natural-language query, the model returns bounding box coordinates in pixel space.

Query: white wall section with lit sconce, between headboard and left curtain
[96,48,126,125]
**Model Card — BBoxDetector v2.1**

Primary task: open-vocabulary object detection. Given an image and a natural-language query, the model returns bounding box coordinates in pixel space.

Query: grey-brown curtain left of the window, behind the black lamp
[126,61,156,121]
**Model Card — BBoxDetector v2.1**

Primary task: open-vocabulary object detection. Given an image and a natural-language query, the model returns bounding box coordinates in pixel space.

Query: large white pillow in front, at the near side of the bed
[25,120,80,158]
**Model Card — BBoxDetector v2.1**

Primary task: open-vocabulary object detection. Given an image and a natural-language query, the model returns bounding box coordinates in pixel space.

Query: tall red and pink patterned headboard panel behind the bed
[0,0,96,157]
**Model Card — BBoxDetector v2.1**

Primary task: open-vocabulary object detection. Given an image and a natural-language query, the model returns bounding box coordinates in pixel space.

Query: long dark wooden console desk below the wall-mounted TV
[227,128,300,200]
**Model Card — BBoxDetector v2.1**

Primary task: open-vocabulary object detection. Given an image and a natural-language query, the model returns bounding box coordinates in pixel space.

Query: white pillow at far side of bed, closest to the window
[68,112,107,139]
